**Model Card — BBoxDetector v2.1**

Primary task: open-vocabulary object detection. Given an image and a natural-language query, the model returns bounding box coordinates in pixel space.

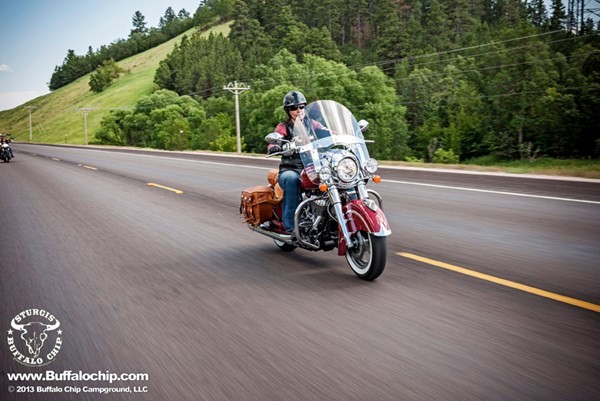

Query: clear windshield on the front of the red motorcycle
[294,100,369,181]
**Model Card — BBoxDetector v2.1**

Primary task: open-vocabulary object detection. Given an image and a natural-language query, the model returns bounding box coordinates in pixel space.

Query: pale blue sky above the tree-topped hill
[0,0,200,110]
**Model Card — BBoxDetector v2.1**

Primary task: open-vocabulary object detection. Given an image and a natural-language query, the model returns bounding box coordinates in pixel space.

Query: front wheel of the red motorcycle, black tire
[346,231,387,281]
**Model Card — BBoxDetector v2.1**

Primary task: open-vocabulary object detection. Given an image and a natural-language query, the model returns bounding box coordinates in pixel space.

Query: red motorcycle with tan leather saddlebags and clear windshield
[240,100,391,281]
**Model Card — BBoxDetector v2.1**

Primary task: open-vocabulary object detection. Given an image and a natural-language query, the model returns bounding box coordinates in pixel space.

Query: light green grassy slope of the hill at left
[0,23,230,144]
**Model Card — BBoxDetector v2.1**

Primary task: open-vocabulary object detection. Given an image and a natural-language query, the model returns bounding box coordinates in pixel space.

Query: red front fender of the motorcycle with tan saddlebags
[338,199,392,255]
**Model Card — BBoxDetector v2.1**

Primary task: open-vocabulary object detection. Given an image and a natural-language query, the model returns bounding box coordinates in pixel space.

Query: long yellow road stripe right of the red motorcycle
[396,252,600,313]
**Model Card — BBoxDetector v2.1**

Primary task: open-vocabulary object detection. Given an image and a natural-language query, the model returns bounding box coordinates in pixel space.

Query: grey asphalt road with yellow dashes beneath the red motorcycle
[0,144,600,401]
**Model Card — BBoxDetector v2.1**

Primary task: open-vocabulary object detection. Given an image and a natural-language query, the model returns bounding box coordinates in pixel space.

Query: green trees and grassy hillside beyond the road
[0,0,600,178]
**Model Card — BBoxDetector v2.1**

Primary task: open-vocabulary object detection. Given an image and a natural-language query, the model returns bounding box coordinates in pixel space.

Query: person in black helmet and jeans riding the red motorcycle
[267,90,306,234]
